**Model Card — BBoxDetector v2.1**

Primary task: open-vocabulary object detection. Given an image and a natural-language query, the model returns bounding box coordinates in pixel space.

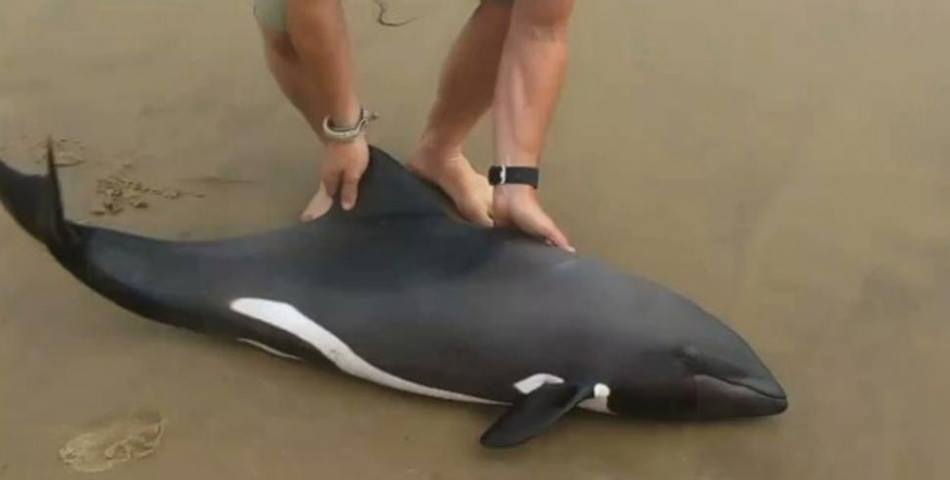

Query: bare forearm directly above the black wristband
[493,0,573,166]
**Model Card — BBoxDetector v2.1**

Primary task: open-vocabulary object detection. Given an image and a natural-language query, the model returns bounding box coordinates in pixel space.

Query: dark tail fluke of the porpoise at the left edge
[0,139,80,259]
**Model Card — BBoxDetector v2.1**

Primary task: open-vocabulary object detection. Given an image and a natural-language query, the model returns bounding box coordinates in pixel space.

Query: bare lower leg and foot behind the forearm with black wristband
[409,0,511,226]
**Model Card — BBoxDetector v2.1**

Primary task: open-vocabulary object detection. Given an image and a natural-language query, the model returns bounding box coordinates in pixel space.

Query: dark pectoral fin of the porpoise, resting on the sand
[481,383,594,448]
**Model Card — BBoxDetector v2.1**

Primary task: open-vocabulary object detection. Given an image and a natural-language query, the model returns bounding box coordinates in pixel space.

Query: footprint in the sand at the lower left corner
[59,411,165,473]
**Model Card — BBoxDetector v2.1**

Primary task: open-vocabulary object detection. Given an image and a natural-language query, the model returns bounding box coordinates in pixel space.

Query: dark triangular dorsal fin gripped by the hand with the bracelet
[342,147,451,217]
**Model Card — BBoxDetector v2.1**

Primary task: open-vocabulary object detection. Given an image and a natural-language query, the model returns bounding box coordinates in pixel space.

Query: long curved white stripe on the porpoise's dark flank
[231,298,499,403]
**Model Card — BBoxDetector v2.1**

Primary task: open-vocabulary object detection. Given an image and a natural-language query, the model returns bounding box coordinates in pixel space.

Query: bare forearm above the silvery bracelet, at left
[287,0,360,132]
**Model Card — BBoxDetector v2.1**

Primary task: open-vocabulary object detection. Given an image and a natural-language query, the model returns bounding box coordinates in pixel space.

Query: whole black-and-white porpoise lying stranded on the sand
[0,145,787,447]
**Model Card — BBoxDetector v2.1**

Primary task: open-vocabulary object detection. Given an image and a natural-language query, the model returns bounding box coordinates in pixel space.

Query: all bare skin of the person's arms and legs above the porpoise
[263,0,574,250]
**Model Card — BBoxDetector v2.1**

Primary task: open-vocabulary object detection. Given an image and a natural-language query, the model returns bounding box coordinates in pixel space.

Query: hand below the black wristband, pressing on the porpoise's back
[492,184,575,253]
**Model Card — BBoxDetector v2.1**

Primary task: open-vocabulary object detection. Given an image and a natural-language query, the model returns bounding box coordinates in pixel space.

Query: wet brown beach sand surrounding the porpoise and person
[0,0,950,480]
